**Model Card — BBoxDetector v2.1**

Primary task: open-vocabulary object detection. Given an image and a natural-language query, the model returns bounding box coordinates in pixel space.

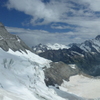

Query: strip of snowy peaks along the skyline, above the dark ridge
[32,35,100,53]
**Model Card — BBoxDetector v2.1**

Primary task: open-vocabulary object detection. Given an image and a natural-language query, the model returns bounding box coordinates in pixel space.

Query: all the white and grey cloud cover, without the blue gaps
[7,0,100,46]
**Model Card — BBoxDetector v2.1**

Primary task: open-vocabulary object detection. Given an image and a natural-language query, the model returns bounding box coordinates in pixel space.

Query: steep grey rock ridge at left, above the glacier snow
[0,23,31,52]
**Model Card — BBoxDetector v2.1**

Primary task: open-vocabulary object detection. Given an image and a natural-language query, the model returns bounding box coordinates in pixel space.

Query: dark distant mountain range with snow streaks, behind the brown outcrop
[33,35,100,76]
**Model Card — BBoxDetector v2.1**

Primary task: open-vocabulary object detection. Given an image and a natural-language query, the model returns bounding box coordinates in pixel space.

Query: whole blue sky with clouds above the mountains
[0,0,100,47]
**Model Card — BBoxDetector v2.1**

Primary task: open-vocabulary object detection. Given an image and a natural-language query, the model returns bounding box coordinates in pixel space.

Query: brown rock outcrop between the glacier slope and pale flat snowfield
[44,62,80,86]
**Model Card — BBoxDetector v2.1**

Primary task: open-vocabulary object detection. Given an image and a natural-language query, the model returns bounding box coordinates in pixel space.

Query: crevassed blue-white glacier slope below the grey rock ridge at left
[0,49,68,100]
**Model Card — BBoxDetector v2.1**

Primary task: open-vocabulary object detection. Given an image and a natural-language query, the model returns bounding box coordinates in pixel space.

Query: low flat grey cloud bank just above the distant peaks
[6,27,98,47]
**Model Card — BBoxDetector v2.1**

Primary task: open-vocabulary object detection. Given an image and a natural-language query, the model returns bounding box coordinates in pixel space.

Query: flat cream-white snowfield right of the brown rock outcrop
[62,75,100,100]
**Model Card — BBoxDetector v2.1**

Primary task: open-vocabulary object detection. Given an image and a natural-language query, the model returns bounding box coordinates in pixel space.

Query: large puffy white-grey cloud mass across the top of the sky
[6,0,100,28]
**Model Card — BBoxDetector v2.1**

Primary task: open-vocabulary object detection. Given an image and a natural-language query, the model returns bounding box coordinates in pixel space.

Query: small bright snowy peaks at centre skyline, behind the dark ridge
[32,43,69,54]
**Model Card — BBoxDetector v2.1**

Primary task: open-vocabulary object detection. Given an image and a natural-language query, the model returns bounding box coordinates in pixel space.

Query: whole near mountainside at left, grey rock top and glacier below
[0,23,87,100]
